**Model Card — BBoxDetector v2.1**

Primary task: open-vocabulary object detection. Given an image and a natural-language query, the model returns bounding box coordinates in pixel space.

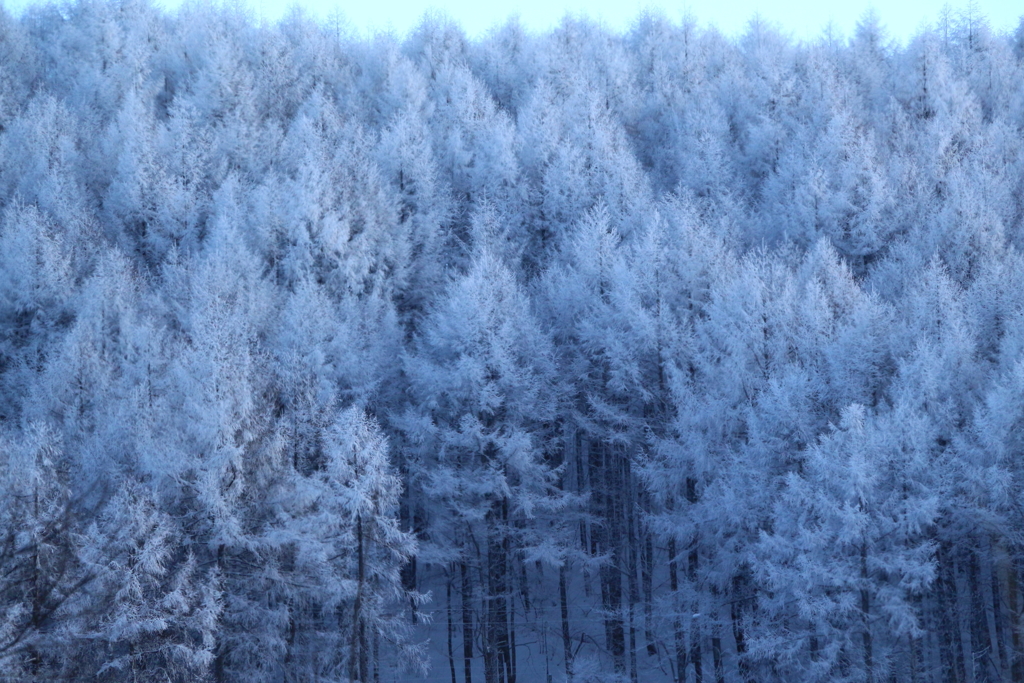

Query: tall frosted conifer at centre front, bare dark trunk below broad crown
[400,236,564,683]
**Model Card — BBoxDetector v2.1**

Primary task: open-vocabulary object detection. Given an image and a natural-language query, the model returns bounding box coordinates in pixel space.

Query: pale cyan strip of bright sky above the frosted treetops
[0,0,1024,41]
